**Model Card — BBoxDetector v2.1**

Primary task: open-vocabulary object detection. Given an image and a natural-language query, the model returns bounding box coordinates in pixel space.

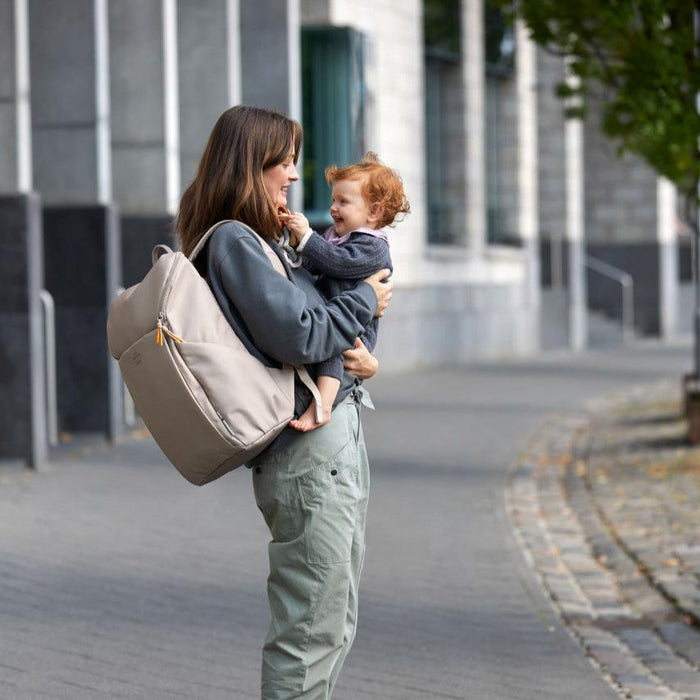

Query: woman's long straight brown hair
[175,105,302,255]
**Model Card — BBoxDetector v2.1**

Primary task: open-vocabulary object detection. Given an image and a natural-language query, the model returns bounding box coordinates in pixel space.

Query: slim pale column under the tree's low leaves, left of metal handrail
[564,98,588,351]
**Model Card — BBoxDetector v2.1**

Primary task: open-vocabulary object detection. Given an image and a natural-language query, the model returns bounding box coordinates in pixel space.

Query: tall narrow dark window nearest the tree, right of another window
[484,0,520,245]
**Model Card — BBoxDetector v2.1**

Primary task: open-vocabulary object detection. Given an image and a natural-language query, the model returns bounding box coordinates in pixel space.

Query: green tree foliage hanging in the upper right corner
[495,0,700,230]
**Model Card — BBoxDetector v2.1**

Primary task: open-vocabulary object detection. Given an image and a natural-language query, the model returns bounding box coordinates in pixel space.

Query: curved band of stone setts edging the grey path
[506,388,700,700]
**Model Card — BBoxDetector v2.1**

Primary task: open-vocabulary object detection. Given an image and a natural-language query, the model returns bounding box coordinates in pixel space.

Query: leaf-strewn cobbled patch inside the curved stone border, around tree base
[585,382,700,628]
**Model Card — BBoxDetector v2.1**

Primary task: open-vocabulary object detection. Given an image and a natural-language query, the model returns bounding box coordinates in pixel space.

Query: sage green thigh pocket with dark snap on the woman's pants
[297,440,360,564]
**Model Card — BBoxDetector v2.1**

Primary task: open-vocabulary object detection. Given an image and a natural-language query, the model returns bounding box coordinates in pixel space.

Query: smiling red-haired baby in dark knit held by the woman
[285,152,410,432]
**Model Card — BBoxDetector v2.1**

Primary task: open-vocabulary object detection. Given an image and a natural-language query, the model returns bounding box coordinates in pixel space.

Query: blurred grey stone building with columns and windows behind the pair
[0,0,691,464]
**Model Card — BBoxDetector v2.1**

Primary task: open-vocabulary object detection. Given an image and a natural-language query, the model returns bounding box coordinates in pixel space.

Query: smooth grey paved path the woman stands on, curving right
[0,344,690,700]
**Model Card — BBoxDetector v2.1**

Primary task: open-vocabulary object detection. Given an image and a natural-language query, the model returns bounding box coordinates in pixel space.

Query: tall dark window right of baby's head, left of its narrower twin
[423,0,466,245]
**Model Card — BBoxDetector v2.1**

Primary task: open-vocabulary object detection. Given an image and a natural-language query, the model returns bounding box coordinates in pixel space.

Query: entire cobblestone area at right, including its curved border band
[508,381,700,700]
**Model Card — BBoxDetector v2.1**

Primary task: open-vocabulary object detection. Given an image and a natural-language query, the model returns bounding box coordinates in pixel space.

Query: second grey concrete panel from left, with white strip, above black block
[29,0,112,204]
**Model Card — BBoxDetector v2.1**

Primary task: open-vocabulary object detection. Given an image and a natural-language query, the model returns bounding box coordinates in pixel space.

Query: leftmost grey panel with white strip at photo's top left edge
[0,0,32,192]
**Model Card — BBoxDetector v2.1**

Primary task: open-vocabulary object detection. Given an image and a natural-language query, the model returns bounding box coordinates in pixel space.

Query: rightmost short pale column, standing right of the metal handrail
[656,178,679,338]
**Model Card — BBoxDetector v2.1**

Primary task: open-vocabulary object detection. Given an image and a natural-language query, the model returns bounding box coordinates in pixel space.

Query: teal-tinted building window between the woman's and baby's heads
[301,27,367,226]
